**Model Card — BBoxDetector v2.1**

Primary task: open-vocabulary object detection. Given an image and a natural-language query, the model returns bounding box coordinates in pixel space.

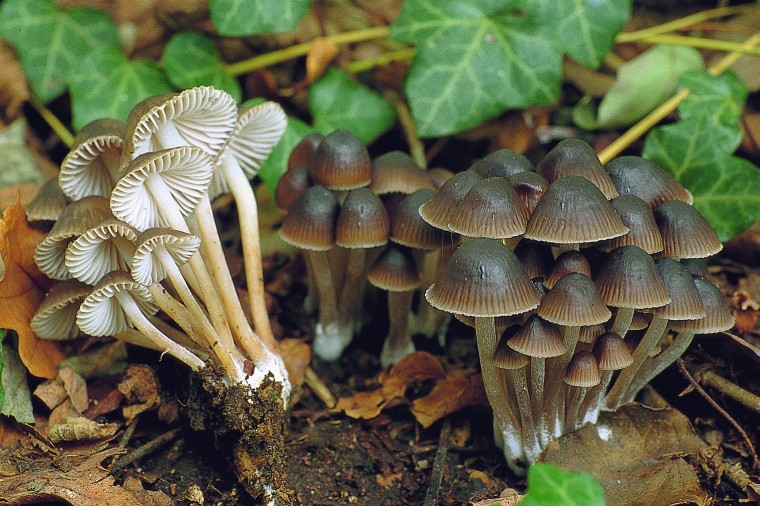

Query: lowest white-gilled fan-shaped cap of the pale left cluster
[77,271,158,336]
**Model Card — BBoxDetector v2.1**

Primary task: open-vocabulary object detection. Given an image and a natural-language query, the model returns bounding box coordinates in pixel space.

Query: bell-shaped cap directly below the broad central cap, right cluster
[594,245,670,309]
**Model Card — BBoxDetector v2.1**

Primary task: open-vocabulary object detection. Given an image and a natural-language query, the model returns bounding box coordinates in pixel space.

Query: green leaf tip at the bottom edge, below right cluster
[517,463,605,506]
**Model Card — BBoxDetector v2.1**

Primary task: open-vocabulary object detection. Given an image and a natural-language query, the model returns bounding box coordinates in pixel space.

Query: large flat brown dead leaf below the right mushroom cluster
[538,404,710,506]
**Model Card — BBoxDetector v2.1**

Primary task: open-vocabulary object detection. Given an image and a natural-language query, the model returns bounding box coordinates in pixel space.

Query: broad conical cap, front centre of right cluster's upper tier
[525,176,628,244]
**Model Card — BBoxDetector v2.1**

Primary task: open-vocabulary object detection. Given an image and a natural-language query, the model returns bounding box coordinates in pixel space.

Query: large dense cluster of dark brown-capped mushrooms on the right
[419,139,733,470]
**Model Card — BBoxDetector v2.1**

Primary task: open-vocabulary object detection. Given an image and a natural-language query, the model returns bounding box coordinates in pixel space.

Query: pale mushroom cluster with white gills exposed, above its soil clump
[27,87,290,502]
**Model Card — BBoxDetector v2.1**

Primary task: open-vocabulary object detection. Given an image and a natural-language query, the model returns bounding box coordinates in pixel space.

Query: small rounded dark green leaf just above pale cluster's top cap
[161,30,243,102]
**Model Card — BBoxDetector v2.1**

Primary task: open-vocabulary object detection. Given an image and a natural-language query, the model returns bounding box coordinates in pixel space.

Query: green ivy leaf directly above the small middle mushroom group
[309,69,396,144]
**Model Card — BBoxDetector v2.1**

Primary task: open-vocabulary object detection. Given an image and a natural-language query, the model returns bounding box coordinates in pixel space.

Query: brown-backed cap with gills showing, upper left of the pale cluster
[58,118,126,200]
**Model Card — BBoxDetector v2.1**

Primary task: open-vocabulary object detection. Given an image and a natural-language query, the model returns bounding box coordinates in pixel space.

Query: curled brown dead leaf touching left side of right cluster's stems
[412,370,488,428]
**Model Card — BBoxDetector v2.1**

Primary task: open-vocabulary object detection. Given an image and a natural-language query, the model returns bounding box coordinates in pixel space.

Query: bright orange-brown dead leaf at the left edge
[0,203,63,379]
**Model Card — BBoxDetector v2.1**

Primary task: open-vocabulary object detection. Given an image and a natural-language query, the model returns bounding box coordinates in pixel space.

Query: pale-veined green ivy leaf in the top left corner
[0,0,118,102]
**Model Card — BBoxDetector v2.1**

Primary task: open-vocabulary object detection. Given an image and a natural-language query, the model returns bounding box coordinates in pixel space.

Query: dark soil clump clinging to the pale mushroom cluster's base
[187,366,293,505]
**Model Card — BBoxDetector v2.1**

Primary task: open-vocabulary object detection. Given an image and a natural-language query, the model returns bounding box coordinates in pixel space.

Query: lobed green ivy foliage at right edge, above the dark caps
[643,73,760,241]
